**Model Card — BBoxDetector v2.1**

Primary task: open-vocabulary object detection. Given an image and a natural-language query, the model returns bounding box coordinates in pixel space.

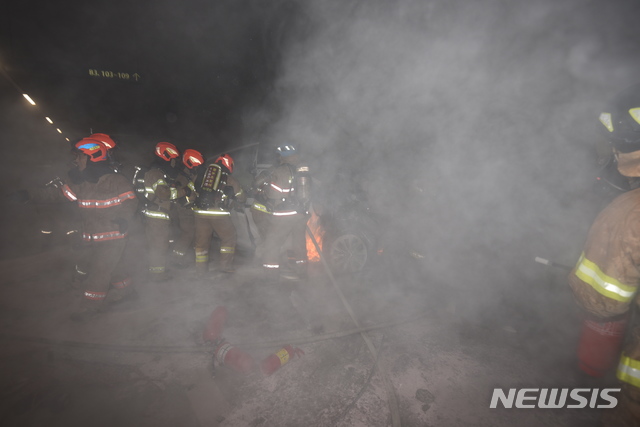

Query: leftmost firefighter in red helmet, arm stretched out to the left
[10,138,137,321]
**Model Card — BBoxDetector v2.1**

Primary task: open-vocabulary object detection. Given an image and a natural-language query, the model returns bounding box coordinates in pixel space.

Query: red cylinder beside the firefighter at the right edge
[578,319,627,377]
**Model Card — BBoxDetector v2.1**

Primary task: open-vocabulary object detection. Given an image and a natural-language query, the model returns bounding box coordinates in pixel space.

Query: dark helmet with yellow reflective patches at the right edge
[599,84,640,153]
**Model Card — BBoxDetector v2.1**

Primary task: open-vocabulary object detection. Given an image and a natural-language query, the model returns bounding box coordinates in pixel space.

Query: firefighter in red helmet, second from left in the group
[142,142,194,282]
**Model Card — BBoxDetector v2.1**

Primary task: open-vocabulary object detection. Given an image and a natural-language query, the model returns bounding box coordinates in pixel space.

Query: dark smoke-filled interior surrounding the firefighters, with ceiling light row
[0,0,640,427]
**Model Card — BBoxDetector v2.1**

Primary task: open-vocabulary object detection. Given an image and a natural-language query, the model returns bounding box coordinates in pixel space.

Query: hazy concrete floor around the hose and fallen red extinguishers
[0,231,615,427]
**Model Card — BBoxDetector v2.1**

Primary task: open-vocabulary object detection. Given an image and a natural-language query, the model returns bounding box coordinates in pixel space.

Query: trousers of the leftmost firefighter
[84,239,133,308]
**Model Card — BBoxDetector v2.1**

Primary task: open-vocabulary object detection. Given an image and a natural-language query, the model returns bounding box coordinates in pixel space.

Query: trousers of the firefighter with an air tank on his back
[195,213,237,275]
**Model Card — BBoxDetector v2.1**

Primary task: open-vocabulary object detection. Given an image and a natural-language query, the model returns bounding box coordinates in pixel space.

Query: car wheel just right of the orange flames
[325,234,369,274]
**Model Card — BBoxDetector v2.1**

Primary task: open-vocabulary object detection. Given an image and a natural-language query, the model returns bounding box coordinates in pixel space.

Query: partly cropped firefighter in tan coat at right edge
[569,85,640,427]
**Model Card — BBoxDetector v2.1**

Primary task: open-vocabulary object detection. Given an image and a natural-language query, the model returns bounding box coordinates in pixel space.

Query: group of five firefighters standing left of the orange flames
[11,133,310,322]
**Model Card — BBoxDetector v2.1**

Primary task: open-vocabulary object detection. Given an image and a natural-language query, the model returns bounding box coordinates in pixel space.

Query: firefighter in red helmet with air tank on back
[193,154,246,277]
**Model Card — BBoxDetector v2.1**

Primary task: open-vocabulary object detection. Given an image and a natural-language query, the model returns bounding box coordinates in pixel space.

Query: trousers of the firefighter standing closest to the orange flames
[262,214,307,278]
